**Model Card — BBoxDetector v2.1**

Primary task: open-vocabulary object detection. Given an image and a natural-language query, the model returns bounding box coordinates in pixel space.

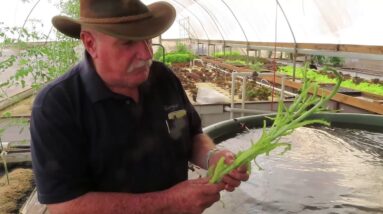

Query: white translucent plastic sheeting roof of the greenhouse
[0,0,383,46]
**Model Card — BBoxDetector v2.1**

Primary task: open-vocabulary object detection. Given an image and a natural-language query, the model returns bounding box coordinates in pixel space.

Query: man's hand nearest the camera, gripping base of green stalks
[167,178,225,214]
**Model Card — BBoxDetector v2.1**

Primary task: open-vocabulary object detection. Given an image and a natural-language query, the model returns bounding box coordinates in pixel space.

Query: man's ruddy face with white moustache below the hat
[93,31,153,88]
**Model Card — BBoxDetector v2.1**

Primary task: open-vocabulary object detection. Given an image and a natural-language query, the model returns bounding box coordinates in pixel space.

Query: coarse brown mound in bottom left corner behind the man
[0,168,34,214]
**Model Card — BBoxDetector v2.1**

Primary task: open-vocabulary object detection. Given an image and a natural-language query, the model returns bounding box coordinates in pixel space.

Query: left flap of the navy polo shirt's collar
[80,51,114,103]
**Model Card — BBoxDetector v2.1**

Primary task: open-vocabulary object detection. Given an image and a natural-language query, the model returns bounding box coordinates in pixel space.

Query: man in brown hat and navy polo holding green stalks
[31,0,248,213]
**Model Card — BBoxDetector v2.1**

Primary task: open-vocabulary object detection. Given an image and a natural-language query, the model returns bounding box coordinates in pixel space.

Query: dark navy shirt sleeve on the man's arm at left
[30,87,90,204]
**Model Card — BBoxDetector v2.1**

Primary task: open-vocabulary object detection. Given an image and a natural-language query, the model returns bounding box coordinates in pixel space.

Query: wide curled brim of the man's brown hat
[52,2,176,41]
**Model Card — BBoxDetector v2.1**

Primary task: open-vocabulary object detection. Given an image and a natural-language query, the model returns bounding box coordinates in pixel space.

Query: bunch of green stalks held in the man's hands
[208,65,342,183]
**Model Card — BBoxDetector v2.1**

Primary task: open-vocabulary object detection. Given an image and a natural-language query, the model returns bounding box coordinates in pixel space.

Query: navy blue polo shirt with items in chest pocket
[30,53,202,204]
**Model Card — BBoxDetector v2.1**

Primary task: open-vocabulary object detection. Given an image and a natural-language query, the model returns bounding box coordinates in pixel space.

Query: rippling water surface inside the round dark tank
[204,127,383,214]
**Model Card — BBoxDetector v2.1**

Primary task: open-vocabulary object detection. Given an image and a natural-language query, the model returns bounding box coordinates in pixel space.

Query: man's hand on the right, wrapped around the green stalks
[208,150,249,192]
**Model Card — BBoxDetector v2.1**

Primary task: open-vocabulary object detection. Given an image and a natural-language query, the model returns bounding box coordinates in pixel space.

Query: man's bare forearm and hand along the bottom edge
[48,178,225,214]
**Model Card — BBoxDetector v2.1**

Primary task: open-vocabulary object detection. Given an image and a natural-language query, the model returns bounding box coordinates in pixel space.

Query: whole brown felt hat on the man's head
[52,0,176,40]
